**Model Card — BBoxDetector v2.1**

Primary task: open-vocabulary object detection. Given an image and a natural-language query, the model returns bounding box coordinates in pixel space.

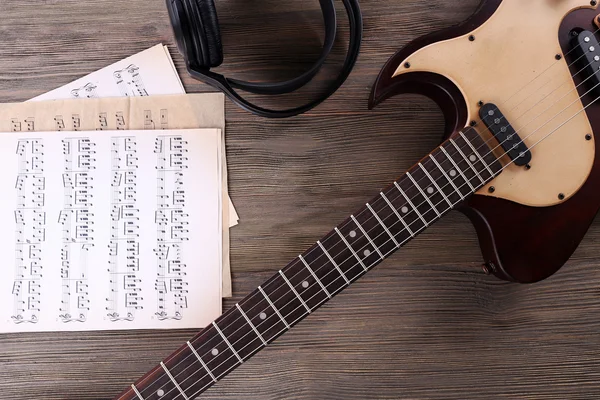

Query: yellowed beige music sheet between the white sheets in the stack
[0,93,238,297]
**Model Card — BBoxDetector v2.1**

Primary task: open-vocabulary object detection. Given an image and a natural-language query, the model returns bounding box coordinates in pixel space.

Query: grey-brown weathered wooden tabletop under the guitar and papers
[0,0,600,400]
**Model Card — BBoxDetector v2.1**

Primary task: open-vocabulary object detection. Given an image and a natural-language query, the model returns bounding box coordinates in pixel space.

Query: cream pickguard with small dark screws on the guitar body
[395,0,600,206]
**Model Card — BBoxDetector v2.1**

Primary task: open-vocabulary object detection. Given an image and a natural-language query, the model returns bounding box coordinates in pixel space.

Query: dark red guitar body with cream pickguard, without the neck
[370,0,600,283]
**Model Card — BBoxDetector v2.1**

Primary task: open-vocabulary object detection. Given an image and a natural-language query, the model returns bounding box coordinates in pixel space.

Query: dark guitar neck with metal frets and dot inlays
[117,129,502,400]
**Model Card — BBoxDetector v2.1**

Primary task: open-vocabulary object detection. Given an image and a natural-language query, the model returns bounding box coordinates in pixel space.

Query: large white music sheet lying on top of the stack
[0,129,223,332]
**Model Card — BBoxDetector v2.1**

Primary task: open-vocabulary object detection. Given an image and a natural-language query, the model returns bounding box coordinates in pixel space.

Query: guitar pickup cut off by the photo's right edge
[572,31,600,96]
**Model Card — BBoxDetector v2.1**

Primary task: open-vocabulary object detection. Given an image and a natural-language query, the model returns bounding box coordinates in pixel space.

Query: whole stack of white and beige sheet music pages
[0,45,232,331]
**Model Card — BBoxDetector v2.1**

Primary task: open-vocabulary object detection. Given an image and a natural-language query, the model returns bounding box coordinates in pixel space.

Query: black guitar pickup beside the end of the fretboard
[479,103,531,166]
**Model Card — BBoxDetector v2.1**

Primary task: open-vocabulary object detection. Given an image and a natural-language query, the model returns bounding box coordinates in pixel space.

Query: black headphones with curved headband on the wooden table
[166,0,363,118]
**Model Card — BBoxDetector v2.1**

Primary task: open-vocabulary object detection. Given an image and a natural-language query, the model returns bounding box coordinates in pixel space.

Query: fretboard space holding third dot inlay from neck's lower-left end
[237,290,289,344]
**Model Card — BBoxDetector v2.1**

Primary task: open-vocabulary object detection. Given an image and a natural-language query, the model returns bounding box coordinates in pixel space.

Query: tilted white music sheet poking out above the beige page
[31,44,185,101]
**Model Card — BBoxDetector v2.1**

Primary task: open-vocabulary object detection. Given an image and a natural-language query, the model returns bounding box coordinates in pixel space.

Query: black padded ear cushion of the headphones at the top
[193,0,223,68]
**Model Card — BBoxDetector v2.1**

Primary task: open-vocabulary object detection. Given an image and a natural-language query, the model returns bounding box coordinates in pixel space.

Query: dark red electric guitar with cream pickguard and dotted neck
[112,0,600,400]
